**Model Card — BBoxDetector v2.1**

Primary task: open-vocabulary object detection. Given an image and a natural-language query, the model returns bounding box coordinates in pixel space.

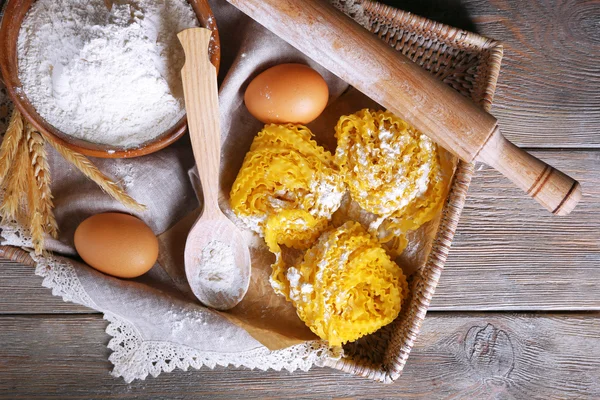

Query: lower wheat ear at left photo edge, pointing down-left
[0,135,29,221]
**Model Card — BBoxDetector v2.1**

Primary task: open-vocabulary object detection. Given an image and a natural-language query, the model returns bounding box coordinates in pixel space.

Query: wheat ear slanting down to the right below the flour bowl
[48,140,146,211]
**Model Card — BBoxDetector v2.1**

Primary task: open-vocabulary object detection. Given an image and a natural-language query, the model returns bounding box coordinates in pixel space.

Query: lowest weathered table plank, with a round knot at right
[0,313,600,399]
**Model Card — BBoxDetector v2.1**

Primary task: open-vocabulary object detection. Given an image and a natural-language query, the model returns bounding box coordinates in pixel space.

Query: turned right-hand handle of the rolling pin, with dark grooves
[477,128,581,215]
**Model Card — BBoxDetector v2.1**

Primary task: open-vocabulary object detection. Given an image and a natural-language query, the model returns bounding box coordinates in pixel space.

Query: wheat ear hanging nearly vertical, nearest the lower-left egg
[26,123,58,238]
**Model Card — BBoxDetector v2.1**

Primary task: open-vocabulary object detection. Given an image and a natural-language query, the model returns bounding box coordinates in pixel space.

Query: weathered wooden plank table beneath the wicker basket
[0,0,600,399]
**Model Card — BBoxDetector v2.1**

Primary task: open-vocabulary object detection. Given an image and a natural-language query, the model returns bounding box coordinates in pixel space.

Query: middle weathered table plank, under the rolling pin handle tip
[0,150,600,313]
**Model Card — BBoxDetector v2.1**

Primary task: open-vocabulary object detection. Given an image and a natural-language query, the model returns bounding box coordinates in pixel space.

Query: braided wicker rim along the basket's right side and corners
[318,0,503,383]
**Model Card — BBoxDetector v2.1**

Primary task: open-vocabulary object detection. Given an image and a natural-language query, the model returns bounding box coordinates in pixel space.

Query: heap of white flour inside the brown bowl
[18,0,199,148]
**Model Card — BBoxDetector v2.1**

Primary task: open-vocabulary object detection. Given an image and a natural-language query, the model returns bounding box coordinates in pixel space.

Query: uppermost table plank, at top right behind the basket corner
[383,0,600,148]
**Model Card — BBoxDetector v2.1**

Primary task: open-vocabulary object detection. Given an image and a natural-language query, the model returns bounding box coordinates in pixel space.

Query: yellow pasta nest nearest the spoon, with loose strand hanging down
[230,124,345,295]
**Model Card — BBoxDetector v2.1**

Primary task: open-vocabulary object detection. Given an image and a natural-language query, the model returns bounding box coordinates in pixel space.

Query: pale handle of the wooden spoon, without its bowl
[177,28,221,213]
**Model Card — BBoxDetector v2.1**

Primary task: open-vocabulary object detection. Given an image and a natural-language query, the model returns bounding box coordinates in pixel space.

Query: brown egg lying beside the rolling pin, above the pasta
[244,64,329,124]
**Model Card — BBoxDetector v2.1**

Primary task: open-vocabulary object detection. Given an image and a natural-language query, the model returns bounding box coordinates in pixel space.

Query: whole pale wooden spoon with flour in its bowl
[177,28,250,310]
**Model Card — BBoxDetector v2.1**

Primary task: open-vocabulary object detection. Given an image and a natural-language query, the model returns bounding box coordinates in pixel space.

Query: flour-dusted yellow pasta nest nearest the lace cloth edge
[286,222,408,346]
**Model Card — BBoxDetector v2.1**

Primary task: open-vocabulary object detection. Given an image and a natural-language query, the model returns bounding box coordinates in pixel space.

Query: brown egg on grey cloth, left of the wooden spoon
[75,213,158,278]
